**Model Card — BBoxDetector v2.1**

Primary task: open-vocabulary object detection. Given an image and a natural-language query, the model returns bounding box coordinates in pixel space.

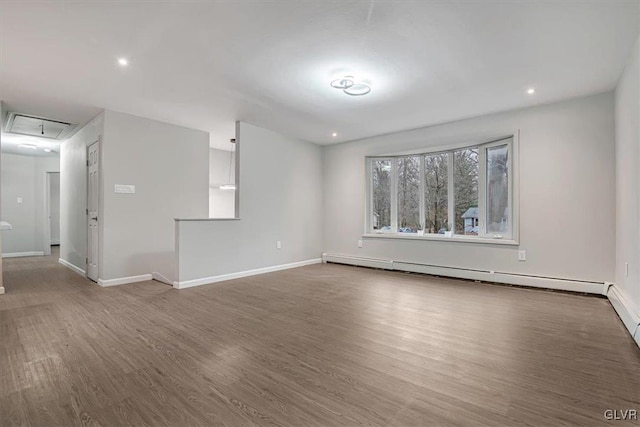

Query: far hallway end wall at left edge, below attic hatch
[0,153,60,255]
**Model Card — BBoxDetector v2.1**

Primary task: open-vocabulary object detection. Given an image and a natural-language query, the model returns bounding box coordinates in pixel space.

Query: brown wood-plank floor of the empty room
[0,254,640,426]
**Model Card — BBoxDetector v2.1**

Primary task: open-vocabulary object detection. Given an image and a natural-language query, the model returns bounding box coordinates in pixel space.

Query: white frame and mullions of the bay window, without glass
[363,131,520,245]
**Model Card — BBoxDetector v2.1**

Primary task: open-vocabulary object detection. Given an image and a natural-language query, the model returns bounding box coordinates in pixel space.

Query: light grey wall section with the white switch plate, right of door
[99,110,209,280]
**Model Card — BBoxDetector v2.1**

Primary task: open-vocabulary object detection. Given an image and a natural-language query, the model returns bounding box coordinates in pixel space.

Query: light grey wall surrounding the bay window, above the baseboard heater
[324,93,616,288]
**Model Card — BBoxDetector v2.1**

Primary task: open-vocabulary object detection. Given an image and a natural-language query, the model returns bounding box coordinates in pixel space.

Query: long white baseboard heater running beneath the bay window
[322,253,607,295]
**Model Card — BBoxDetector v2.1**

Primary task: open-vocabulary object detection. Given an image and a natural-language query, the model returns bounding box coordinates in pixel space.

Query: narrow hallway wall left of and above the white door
[60,113,104,271]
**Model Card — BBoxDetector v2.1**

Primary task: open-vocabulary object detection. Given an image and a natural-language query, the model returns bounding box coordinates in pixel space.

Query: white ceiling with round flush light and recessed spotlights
[0,0,639,148]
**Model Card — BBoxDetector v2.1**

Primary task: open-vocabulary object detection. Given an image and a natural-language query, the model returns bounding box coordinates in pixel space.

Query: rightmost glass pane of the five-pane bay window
[487,145,509,233]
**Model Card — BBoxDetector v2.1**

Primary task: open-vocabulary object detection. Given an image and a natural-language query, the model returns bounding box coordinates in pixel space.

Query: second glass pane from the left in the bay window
[398,156,420,233]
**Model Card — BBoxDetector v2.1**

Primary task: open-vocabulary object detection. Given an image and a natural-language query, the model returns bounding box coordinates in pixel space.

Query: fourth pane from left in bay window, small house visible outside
[453,148,478,236]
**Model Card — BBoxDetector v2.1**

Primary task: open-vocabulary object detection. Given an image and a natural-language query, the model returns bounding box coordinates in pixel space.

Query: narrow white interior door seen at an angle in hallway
[87,141,100,282]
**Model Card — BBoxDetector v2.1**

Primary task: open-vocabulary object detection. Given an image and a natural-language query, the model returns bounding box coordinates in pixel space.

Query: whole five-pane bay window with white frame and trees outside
[367,137,517,240]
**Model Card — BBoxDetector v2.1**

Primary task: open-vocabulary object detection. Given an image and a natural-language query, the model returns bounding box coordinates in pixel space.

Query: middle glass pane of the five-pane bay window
[424,153,449,234]
